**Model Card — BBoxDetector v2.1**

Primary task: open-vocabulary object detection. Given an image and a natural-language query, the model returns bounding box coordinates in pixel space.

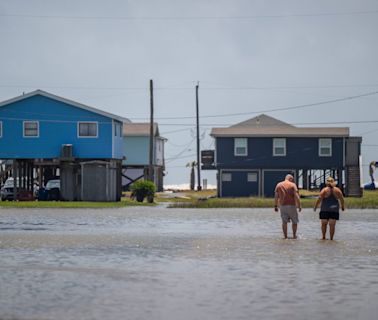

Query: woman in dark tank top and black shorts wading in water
[314,177,345,240]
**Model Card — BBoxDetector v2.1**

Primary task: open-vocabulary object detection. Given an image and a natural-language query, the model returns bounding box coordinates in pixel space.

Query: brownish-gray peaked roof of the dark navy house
[210,114,349,137]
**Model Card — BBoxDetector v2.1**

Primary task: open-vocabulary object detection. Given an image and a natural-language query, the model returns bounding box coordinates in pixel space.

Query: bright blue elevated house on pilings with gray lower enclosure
[0,90,130,201]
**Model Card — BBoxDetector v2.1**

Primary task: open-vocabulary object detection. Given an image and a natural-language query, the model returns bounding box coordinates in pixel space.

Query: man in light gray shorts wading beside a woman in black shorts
[274,174,302,239]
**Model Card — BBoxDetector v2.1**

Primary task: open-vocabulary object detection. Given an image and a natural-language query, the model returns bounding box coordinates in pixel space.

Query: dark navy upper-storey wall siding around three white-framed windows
[216,137,344,169]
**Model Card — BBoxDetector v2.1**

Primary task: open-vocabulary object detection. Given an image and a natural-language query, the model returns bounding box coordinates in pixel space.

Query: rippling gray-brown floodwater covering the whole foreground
[0,207,378,320]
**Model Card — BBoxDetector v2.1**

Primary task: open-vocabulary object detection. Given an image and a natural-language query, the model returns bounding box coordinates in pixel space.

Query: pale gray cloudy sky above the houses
[0,0,378,184]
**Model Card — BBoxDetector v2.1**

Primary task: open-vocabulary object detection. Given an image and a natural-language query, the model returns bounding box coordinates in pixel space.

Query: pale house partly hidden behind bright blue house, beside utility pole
[122,123,167,191]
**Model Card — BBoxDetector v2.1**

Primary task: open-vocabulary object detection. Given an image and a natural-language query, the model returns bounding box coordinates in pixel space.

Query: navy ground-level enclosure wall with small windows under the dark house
[219,170,260,197]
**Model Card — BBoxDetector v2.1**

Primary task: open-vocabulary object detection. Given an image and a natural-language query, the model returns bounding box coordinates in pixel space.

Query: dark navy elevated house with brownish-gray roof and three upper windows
[202,114,362,197]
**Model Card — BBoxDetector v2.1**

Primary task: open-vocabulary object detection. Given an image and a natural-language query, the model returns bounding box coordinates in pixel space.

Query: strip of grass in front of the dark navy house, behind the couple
[169,191,378,209]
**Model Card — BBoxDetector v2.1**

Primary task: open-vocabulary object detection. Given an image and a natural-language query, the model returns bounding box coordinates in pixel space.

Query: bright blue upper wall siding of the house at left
[0,95,122,159]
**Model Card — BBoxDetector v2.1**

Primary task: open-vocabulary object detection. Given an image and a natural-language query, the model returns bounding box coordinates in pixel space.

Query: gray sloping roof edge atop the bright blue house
[0,90,130,123]
